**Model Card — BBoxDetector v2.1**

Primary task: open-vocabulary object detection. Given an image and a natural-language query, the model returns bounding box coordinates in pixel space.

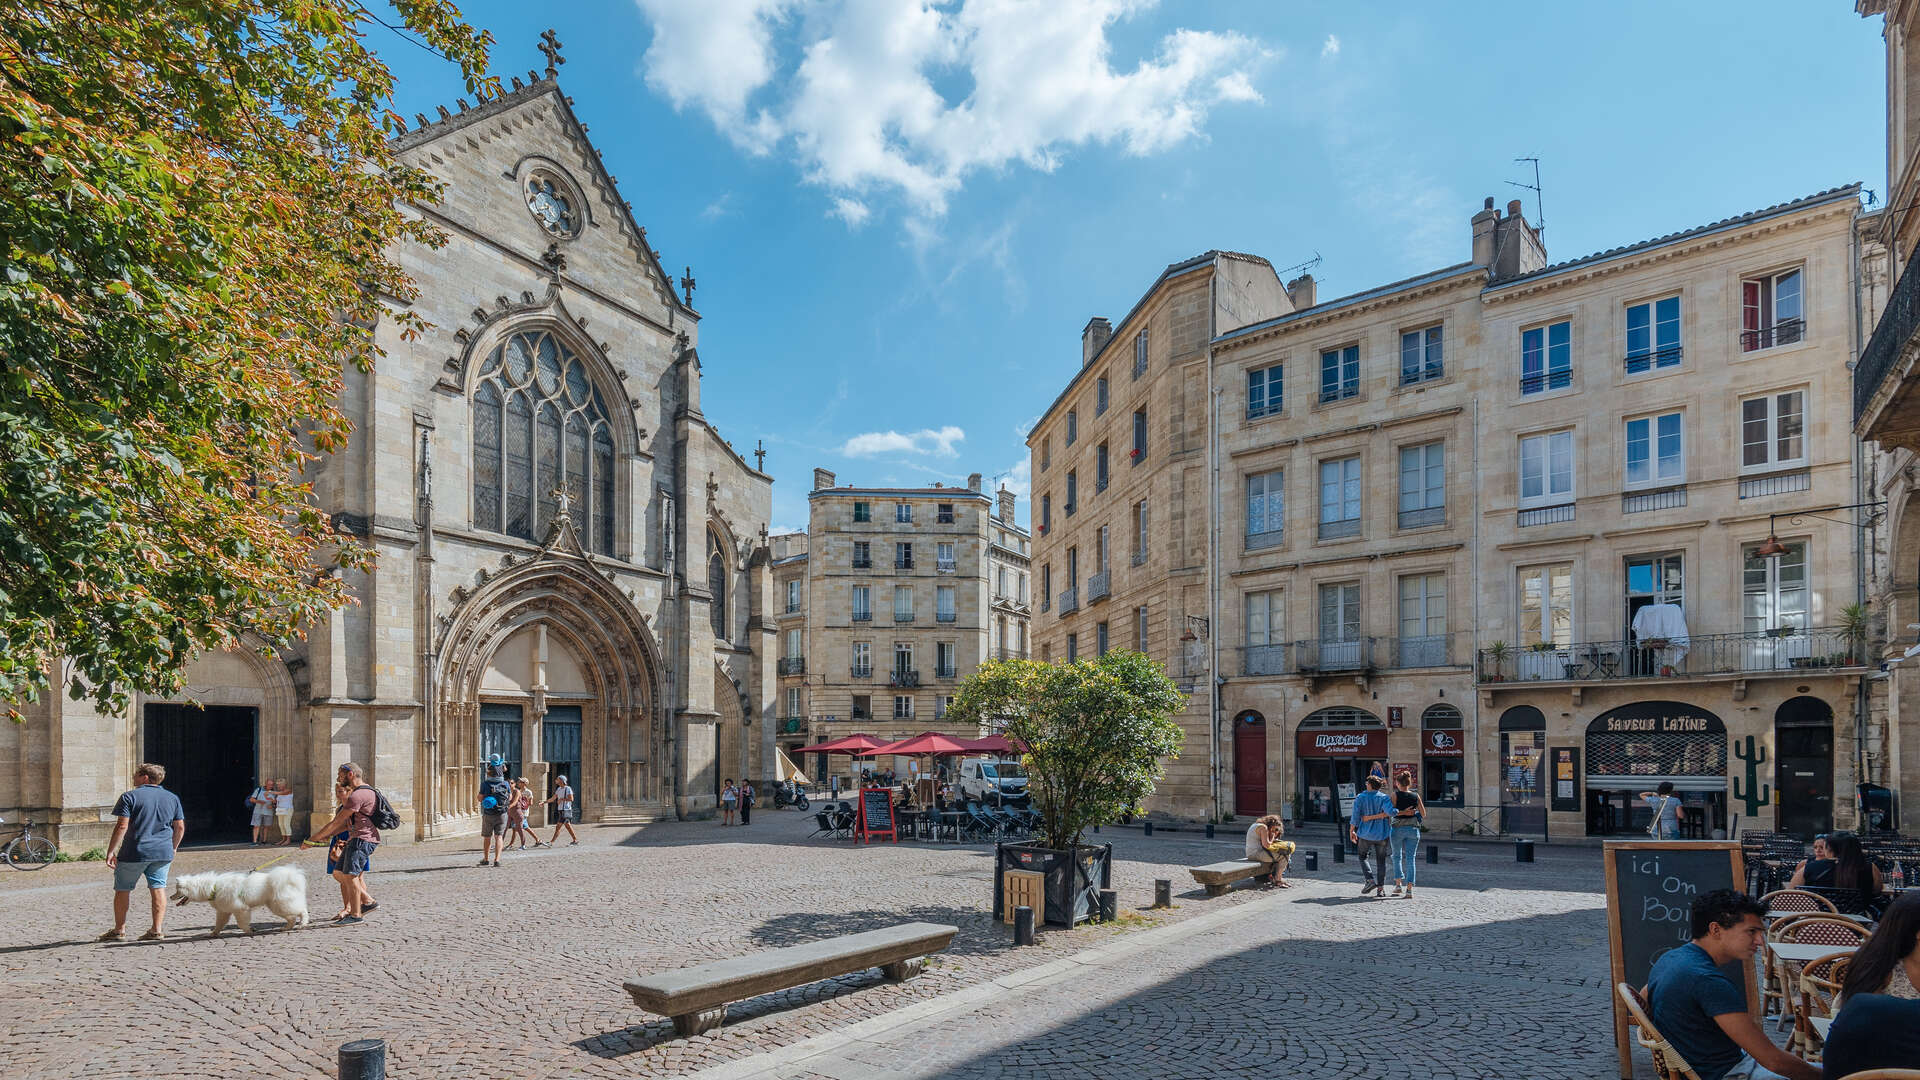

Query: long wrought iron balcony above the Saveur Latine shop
[1475,626,1866,682]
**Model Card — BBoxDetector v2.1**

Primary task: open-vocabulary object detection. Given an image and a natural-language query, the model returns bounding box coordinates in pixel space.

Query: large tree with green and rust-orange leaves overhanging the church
[0,0,497,719]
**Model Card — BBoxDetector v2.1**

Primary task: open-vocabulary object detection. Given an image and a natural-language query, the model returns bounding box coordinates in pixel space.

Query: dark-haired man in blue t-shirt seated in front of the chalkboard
[1642,888,1820,1080]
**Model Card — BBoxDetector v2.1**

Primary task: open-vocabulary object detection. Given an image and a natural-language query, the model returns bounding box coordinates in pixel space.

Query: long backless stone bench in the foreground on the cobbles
[626,922,958,1036]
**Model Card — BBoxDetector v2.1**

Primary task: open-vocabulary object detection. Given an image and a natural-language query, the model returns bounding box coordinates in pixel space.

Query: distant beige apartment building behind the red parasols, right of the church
[774,469,1033,780]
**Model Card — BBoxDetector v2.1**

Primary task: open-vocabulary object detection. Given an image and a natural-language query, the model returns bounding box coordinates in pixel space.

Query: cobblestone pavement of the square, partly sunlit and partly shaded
[0,811,1681,1080]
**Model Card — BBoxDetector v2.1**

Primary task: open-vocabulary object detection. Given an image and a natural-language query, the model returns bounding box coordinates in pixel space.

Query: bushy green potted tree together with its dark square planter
[947,650,1187,926]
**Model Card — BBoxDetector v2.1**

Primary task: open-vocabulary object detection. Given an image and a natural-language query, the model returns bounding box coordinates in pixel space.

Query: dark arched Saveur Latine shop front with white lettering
[1586,701,1728,840]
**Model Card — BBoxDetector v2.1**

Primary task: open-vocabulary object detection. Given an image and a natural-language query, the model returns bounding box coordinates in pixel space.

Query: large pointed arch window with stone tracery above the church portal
[472,331,614,555]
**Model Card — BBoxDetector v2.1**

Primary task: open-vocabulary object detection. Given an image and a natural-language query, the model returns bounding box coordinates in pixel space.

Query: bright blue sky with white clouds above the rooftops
[371,0,1885,528]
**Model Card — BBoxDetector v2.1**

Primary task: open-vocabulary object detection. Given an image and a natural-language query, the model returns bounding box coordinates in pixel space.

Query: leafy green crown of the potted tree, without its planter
[947,650,1187,851]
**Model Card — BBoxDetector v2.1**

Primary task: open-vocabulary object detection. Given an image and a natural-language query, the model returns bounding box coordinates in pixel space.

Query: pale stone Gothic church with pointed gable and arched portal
[0,31,776,849]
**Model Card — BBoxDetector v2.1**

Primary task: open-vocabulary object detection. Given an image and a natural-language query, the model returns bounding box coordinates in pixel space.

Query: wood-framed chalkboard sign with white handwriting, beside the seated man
[1607,840,1761,1080]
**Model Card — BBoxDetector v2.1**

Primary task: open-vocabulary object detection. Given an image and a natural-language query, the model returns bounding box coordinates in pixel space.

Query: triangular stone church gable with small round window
[396,56,697,327]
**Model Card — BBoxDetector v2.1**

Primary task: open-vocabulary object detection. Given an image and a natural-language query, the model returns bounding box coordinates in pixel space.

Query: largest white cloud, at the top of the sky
[636,0,1271,227]
